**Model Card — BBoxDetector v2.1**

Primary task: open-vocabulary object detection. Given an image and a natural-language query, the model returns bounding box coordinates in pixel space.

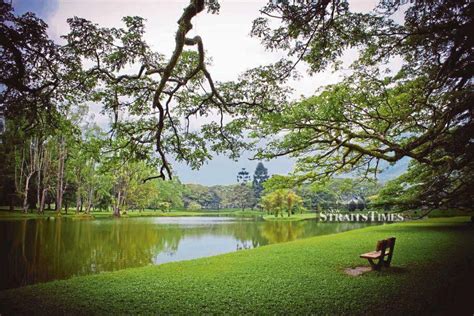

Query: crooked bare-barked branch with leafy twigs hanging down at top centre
[65,0,286,179]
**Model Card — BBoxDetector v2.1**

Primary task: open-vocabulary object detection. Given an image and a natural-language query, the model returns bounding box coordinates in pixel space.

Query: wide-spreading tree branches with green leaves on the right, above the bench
[249,0,474,212]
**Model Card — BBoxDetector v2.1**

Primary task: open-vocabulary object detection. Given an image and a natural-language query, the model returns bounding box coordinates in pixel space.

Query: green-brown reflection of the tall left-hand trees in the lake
[0,218,184,288]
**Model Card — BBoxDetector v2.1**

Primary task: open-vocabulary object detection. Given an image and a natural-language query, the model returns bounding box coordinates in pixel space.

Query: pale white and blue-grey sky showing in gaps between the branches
[12,0,407,185]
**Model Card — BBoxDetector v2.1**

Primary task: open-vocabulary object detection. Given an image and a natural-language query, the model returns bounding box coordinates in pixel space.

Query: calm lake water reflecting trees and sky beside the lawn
[0,217,374,289]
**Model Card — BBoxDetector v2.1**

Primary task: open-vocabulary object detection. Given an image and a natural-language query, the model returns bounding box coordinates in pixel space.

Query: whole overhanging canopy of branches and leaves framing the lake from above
[0,0,474,214]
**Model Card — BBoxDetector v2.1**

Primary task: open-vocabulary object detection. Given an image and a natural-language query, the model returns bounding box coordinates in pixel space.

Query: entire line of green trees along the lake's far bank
[0,116,378,216]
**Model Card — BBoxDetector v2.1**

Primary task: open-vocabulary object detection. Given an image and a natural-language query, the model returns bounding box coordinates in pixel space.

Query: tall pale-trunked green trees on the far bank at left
[0,109,181,216]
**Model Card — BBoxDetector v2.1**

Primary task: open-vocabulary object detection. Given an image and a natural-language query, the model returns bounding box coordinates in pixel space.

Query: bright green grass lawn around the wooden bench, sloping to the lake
[0,217,474,315]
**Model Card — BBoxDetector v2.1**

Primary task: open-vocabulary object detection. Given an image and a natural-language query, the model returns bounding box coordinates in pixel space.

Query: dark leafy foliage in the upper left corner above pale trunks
[0,1,83,129]
